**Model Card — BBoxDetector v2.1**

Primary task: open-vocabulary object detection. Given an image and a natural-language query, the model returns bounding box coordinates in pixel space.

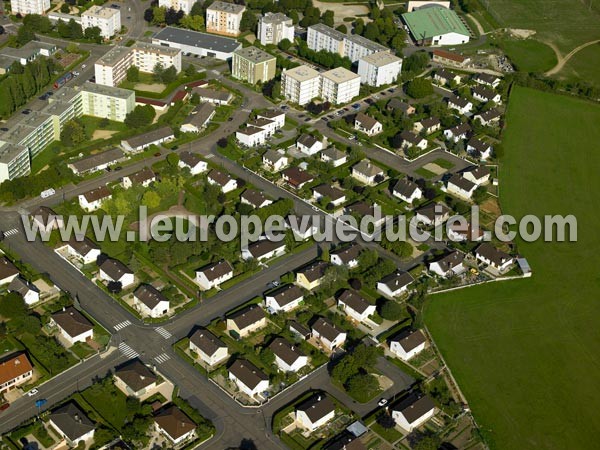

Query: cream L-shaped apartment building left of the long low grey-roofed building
[94,42,181,86]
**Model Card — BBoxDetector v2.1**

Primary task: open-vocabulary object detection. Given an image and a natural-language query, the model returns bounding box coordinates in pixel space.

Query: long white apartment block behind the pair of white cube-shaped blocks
[306,23,390,62]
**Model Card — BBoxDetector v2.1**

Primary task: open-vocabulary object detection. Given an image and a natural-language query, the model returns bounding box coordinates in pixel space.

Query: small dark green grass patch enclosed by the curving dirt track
[500,39,558,72]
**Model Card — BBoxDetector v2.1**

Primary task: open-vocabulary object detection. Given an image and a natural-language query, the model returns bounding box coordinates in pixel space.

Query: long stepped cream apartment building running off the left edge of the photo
[0,83,135,183]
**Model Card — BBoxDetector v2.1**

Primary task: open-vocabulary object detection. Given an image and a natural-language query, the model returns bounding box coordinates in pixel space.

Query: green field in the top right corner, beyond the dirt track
[484,0,600,54]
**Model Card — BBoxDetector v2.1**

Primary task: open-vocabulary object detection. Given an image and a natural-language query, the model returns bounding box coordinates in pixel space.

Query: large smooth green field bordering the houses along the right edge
[424,88,600,450]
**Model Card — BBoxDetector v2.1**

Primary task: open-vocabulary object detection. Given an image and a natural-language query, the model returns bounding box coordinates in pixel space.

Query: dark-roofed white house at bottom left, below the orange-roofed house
[48,400,95,447]
